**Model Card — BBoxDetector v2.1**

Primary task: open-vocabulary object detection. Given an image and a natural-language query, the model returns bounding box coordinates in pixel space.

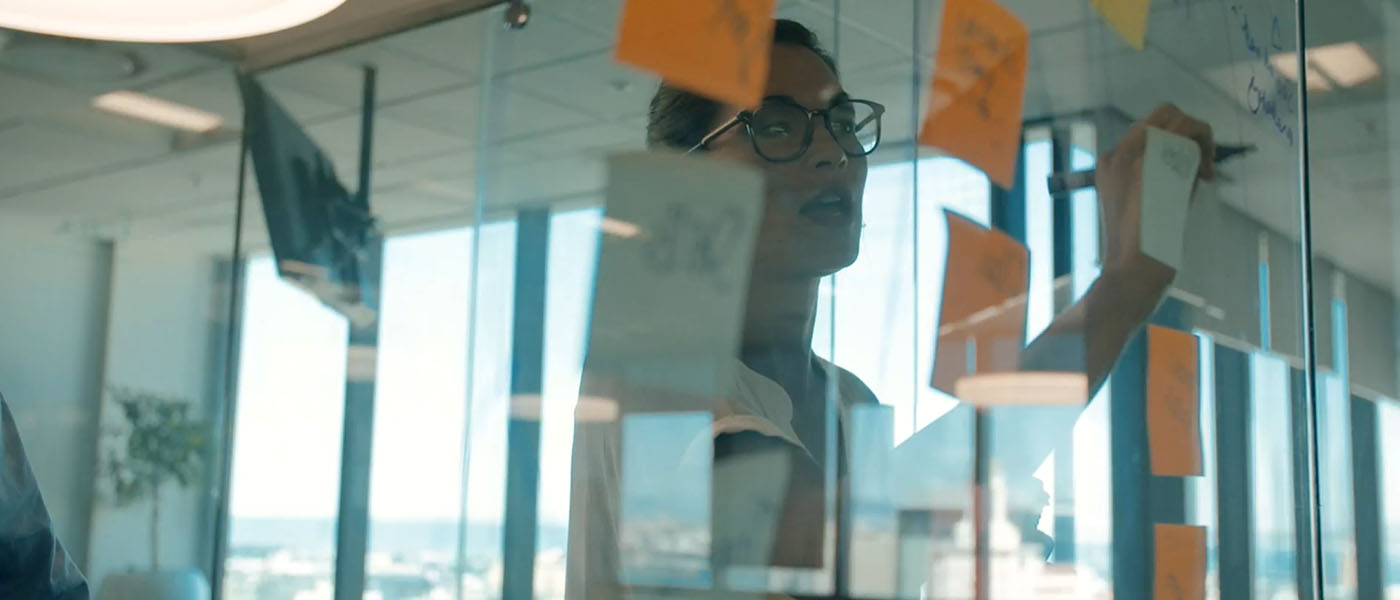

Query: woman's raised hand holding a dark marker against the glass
[1095,103,1215,276]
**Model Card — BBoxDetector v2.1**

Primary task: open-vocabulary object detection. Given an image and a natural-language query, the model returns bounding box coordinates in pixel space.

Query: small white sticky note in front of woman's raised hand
[1140,127,1201,270]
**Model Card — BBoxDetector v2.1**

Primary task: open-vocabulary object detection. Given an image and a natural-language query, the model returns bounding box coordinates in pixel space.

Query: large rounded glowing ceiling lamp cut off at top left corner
[0,0,344,42]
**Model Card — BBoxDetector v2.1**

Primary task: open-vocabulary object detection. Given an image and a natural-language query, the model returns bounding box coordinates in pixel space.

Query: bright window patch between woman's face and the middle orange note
[812,157,991,443]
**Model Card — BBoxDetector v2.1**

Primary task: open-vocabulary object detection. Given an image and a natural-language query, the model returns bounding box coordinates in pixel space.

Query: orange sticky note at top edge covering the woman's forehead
[613,0,777,106]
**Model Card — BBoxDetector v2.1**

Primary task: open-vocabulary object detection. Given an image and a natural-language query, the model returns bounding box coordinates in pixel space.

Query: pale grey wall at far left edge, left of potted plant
[0,222,111,565]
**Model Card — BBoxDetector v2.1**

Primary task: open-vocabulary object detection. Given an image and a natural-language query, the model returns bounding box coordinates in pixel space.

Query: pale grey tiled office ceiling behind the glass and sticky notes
[0,0,1400,293]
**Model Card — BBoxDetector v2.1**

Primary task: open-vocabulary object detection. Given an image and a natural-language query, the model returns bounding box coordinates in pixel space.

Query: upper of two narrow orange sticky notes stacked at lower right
[1147,324,1201,477]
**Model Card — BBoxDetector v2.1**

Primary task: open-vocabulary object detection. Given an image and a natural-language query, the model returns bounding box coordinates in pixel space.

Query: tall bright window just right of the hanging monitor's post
[365,229,473,600]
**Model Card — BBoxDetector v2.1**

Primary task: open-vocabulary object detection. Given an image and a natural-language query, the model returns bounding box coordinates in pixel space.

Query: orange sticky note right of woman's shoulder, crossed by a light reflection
[932,210,1030,394]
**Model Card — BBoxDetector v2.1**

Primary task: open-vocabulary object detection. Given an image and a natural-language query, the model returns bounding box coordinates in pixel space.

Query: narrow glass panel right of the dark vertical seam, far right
[1288,3,1400,599]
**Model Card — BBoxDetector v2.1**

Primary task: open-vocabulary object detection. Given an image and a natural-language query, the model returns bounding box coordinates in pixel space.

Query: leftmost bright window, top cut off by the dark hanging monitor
[223,256,347,600]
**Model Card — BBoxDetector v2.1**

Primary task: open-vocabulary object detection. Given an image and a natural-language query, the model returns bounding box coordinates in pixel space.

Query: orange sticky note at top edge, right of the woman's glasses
[918,0,1030,187]
